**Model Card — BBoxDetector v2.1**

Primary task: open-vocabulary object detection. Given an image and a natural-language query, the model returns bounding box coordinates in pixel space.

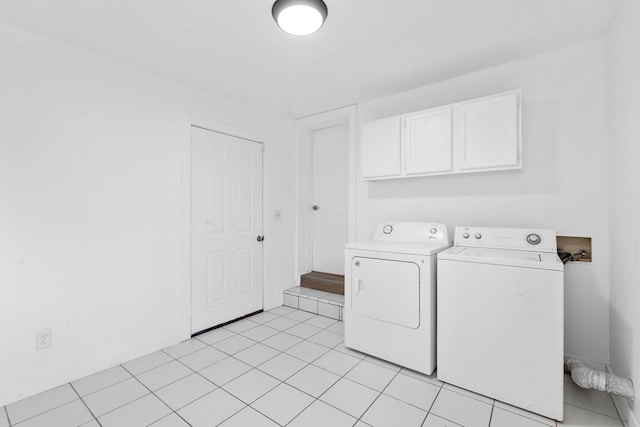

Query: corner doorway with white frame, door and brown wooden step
[296,106,356,294]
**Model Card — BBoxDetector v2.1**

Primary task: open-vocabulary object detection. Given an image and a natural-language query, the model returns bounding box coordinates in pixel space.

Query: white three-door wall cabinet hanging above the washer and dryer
[361,90,522,181]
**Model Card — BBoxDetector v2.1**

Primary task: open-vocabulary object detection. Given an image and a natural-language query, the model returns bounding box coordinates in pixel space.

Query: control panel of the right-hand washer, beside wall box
[454,227,557,253]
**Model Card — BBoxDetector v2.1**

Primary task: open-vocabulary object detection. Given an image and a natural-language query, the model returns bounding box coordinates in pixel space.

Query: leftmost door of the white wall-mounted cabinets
[362,117,400,179]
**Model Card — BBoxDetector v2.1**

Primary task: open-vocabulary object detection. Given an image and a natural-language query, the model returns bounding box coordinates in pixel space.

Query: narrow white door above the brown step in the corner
[311,124,349,275]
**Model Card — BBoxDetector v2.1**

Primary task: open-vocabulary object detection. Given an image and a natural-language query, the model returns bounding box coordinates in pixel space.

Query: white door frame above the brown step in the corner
[295,105,357,280]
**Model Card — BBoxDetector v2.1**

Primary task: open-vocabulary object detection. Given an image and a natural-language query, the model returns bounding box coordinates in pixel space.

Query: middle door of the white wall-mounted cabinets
[405,108,453,175]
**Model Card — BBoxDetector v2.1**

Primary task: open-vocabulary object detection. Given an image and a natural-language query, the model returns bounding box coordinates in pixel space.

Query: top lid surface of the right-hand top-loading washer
[438,246,564,271]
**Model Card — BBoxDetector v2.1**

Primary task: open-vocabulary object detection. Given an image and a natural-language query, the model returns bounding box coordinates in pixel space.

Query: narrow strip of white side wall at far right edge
[608,0,640,418]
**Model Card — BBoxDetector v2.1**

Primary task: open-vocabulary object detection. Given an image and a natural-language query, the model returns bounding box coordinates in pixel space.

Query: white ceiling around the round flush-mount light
[0,0,618,117]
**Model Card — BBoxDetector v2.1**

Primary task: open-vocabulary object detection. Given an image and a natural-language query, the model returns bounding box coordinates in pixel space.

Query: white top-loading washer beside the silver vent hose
[438,227,564,420]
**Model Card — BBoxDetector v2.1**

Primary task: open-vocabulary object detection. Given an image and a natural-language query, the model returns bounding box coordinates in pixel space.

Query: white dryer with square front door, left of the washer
[344,222,451,374]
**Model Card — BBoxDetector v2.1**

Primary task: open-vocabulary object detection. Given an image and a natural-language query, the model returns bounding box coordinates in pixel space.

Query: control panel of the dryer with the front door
[373,222,449,243]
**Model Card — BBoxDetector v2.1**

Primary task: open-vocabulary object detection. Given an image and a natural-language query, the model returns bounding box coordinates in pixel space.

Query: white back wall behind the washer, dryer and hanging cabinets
[356,40,609,363]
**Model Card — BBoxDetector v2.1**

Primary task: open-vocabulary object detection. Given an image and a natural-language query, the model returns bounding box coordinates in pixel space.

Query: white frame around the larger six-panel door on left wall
[178,113,269,341]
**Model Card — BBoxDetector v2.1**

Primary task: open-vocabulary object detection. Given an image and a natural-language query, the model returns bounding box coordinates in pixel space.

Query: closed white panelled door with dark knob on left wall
[191,127,262,333]
